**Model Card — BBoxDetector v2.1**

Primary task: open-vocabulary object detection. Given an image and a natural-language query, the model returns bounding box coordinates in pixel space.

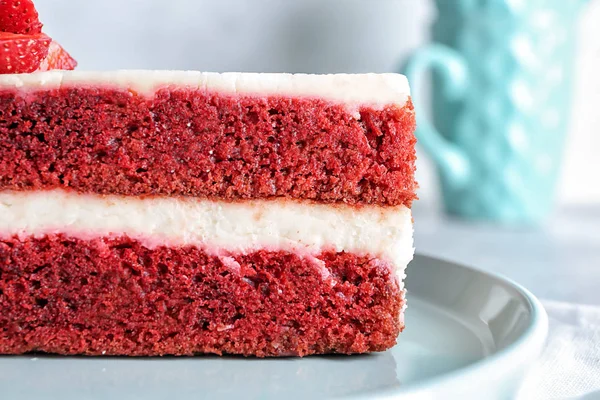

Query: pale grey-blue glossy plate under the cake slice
[0,256,547,400]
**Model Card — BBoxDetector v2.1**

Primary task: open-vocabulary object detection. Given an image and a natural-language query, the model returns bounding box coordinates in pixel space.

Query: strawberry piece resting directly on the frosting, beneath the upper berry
[0,32,52,74]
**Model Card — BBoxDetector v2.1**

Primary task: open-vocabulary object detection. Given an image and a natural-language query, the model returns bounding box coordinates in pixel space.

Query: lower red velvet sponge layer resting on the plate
[0,235,404,357]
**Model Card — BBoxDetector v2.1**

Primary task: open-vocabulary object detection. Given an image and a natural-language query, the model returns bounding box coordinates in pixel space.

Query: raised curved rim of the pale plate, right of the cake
[366,253,548,400]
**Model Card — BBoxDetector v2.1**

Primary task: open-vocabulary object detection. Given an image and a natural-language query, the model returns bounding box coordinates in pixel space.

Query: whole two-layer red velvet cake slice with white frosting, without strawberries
[0,71,416,357]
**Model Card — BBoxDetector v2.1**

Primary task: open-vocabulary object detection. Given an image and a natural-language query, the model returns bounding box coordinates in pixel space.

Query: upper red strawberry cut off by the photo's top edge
[0,0,42,35]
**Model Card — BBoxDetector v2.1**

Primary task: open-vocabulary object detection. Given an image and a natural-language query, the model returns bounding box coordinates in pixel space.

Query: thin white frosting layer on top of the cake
[0,70,410,106]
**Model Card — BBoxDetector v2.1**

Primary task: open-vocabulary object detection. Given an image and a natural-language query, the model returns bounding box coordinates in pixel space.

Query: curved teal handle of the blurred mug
[403,44,471,187]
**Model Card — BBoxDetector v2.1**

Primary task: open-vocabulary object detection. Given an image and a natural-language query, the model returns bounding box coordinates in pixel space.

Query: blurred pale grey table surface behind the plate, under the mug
[413,202,600,305]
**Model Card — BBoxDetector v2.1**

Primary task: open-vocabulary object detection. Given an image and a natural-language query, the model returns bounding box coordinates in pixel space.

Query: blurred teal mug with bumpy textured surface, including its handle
[404,0,584,224]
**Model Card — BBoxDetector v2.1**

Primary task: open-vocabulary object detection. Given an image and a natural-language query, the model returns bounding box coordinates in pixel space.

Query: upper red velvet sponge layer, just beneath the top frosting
[0,88,416,206]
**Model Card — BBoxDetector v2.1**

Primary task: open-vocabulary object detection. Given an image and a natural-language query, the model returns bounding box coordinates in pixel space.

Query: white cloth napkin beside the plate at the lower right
[519,301,600,400]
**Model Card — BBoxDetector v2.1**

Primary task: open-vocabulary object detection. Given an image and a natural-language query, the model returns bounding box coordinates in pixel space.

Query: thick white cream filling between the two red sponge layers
[0,190,413,278]
